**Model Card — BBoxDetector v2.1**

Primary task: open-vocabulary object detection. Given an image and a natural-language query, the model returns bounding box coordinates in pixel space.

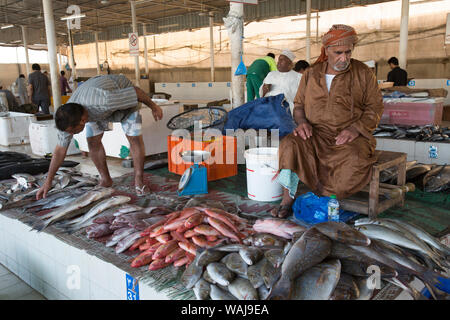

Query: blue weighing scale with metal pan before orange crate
[178,150,211,196]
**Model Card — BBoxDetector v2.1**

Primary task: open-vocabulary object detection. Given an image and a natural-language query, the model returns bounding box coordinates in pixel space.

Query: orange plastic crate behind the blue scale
[167,135,237,181]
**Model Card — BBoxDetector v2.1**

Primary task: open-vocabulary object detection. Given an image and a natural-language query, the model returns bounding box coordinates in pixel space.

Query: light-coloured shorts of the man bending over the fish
[85,111,142,138]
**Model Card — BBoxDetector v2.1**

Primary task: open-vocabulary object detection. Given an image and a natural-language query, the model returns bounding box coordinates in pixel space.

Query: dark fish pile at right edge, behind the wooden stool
[380,161,450,192]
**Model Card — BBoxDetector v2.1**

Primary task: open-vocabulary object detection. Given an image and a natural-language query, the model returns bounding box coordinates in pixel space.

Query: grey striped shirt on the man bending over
[58,74,139,148]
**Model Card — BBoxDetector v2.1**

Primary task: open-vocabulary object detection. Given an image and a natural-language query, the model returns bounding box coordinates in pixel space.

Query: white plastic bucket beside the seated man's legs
[244,148,283,202]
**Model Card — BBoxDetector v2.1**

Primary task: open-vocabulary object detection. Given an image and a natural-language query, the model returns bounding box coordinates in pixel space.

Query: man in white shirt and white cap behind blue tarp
[261,50,302,114]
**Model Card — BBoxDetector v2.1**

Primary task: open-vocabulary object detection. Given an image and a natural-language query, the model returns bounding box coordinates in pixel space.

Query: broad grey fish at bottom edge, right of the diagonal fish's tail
[291,259,341,300]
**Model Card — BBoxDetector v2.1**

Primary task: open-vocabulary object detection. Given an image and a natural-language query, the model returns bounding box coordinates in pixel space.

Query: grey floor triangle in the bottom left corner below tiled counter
[0,264,47,300]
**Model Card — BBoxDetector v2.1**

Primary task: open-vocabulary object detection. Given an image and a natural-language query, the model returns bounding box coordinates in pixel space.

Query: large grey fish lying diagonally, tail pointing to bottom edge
[269,228,332,300]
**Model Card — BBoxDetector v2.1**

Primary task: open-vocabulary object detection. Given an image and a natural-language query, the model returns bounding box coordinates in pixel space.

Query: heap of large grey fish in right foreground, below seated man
[181,219,450,300]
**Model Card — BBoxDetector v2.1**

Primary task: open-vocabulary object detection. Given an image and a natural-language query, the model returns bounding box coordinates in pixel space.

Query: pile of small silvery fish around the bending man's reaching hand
[0,167,98,209]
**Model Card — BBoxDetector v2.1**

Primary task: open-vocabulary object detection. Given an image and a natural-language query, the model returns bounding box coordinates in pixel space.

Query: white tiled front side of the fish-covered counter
[0,214,168,300]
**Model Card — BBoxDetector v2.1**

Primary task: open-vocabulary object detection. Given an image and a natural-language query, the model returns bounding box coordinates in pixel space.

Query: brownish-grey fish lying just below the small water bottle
[312,221,370,246]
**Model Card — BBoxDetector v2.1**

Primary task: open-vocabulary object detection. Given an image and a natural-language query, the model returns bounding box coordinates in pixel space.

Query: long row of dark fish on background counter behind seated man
[373,124,450,142]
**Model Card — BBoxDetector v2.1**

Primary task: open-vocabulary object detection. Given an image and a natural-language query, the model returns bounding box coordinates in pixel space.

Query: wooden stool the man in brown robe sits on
[339,150,412,219]
